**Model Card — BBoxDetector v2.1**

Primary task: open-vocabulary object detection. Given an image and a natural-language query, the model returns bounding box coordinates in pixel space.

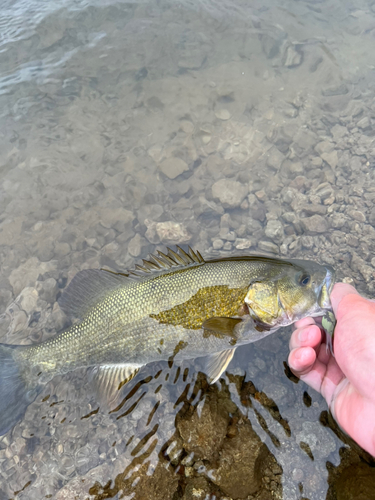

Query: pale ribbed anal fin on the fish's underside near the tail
[90,365,142,410]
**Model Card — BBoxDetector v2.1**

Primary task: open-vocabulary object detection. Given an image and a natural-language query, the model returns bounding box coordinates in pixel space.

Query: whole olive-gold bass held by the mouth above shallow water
[0,246,335,435]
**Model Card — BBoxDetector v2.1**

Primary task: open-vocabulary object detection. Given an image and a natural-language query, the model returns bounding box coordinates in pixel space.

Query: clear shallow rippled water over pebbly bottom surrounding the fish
[0,0,375,500]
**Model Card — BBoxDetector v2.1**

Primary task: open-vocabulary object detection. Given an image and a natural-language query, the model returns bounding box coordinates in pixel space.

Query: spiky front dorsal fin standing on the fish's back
[119,245,204,278]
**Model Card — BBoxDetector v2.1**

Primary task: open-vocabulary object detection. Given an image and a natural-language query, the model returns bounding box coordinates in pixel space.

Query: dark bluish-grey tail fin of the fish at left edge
[0,344,38,436]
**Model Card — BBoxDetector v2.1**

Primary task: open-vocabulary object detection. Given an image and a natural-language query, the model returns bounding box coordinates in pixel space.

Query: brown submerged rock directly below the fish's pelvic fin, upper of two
[176,394,229,460]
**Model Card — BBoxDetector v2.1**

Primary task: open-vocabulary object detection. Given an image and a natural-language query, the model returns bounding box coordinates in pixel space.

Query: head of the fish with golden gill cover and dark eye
[245,260,335,330]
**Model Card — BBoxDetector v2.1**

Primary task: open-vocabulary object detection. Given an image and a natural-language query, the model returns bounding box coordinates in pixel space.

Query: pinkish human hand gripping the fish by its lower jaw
[288,283,375,456]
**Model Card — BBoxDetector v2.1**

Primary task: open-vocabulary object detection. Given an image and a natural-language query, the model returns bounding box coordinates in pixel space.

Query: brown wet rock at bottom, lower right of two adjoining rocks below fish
[212,420,269,498]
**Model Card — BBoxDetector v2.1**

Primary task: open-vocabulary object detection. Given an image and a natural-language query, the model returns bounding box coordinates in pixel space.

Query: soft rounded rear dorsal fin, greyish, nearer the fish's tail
[58,269,130,318]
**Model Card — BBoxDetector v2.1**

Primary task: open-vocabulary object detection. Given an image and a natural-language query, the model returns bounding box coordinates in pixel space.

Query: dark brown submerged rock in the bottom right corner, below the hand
[335,463,375,500]
